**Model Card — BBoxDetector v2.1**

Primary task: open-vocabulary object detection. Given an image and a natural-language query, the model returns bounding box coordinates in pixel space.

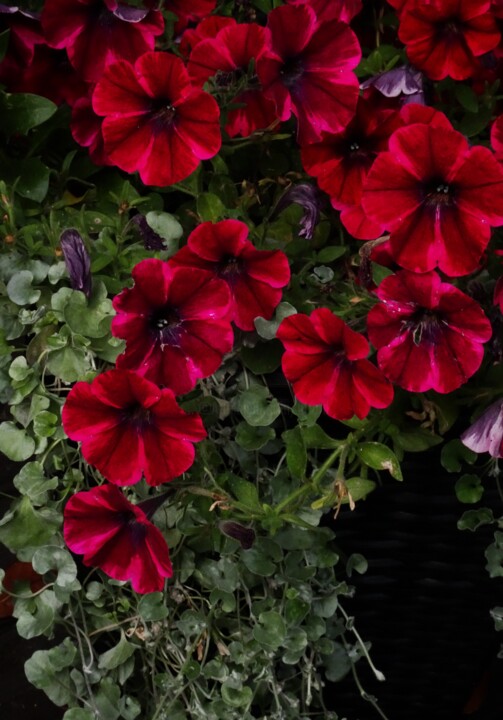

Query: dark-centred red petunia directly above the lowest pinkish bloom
[62,369,206,485]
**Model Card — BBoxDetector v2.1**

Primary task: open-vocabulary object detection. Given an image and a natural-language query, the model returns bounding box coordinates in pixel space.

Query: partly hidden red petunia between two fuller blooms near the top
[187,23,276,137]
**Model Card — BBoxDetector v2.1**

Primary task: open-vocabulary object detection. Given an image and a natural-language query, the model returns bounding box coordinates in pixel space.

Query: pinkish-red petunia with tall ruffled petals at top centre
[257,4,361,144]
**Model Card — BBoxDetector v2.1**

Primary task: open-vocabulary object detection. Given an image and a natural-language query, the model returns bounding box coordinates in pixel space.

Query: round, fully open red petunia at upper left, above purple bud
[93,52,222,186]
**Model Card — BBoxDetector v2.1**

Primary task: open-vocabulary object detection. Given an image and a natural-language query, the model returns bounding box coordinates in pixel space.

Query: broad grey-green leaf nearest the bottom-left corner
[24,638,77,707]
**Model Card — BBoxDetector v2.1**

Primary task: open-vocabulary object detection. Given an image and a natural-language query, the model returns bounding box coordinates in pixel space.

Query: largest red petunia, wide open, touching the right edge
[362,118,503,276]
